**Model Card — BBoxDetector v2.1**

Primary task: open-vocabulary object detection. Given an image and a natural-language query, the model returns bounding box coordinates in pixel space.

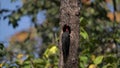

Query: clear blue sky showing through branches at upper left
[0,0,45,44]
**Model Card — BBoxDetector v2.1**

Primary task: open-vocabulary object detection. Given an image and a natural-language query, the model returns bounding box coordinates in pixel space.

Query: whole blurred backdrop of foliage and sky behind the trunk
[0,0,120,68]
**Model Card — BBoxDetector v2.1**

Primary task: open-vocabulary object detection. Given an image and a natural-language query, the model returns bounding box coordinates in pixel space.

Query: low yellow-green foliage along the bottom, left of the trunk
[0,44,58,68]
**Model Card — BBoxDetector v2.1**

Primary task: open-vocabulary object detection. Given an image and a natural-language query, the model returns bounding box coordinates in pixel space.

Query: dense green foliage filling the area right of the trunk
[80,1,120,68]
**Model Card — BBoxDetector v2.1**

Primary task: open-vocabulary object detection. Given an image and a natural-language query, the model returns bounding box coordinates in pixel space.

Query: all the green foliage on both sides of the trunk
[0,0,120,68]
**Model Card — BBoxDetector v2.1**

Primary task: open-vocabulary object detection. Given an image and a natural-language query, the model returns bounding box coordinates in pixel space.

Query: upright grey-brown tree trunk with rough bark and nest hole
[59,0,80,68]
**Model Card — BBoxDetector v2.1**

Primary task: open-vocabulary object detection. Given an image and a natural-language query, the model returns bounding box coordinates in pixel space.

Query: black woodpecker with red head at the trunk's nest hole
[62,25,71,63]
